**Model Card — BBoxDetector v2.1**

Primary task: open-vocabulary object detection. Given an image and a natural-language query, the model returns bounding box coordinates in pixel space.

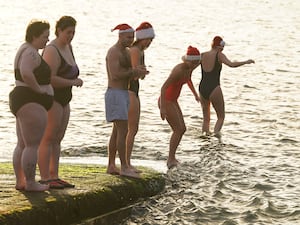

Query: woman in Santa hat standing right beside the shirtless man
[126,22,155,172]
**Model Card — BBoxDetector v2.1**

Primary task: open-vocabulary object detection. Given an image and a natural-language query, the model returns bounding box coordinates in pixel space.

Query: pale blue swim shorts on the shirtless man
[105,88,129,122]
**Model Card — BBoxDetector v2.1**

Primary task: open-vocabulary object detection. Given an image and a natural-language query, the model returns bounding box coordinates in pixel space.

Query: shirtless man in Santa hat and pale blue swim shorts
[105,24,147,178]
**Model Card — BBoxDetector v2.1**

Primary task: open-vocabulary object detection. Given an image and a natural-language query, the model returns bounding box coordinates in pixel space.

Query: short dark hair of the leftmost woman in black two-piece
[25,20,50,43]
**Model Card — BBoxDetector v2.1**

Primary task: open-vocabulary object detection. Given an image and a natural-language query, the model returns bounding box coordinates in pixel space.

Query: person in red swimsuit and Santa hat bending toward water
[158,46,200,169]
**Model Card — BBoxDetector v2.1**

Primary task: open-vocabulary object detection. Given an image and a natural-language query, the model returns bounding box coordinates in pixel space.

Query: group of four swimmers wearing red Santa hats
[105,22,254,178]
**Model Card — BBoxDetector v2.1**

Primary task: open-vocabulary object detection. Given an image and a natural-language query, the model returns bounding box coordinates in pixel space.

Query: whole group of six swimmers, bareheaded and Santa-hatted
[9,16,254,191]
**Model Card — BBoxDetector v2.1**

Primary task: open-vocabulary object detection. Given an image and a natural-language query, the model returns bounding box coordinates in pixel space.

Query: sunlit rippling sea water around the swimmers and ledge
[0,0,300,224]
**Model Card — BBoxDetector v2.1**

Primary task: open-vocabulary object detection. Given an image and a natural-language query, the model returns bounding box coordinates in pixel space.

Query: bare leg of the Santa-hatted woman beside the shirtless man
[126,91,141,172]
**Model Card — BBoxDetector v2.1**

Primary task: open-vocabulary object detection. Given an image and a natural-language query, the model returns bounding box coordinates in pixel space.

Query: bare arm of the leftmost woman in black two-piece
[19,49,43,94]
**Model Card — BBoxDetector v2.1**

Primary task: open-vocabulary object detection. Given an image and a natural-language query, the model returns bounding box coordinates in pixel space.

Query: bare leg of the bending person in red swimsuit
[167,102,186,168]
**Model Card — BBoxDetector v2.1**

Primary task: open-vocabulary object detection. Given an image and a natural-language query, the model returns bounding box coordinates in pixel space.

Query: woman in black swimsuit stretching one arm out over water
[199,36,254,140]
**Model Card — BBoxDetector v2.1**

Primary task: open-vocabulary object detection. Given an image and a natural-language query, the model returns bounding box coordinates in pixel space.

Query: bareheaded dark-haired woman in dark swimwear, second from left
[38,16,83,189]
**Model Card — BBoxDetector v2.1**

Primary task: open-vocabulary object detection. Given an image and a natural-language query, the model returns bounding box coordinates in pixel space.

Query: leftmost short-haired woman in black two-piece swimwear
[9,21,53,191]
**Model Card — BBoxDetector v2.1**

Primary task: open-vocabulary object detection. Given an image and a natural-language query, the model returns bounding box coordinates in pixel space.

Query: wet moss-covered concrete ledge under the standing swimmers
[0,163,165,225]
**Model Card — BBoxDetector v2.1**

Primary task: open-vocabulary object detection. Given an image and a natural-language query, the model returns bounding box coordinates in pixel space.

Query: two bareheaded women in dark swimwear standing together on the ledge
[9,16,83,191]
